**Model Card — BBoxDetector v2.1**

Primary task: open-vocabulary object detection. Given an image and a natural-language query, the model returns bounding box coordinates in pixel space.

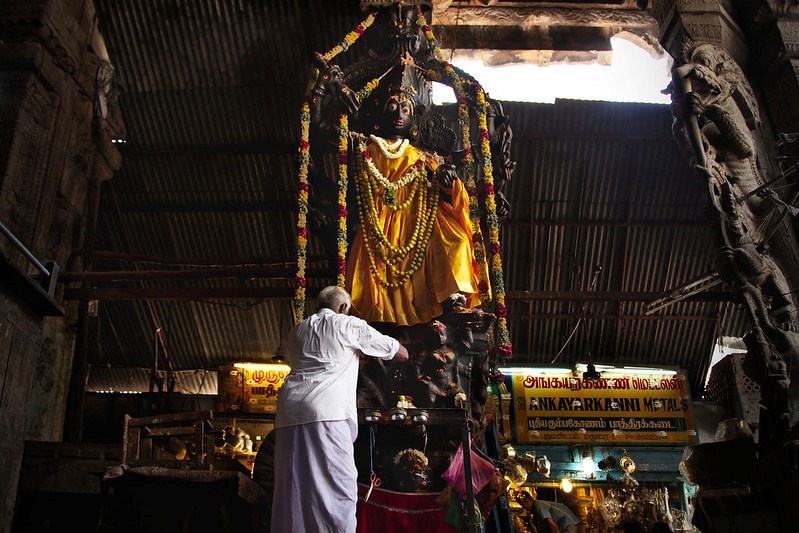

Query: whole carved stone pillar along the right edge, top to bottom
[654,0,799,530]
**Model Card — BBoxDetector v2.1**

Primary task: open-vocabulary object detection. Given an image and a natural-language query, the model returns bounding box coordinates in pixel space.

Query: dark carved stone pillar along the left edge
[0,0,120,532]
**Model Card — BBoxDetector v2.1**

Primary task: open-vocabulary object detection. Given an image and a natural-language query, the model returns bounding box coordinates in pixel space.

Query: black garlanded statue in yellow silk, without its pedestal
[308,2,515,328]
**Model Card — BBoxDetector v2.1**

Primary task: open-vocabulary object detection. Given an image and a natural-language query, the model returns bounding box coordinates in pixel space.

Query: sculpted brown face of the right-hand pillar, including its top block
[655,0,799,432]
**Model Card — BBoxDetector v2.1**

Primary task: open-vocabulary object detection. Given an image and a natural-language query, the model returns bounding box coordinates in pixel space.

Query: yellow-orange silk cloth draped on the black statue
[346,137,488,326]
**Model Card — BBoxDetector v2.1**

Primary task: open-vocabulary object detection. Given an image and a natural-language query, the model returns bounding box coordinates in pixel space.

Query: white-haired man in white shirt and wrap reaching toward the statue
[272,286,408,533]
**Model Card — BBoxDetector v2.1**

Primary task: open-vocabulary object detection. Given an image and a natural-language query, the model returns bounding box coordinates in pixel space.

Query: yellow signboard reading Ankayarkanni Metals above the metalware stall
[505,368,697,444]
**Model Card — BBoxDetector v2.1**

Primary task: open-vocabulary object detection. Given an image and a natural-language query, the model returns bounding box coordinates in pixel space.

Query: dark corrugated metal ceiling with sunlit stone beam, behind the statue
[72,0,746,396]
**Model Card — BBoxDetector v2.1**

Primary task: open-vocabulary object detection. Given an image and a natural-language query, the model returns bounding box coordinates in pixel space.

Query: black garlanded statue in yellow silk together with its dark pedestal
[295,8,515,520]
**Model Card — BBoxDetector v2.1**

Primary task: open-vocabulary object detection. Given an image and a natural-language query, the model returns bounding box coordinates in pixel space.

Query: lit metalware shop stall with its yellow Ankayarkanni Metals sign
[493,364,699,533]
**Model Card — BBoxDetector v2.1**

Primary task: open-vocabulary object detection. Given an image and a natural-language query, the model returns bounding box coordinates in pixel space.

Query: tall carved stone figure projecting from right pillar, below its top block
[669,43,799,439]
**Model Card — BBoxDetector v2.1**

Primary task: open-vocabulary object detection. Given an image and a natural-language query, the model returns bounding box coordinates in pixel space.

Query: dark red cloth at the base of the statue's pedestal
[357,484,457,533]
